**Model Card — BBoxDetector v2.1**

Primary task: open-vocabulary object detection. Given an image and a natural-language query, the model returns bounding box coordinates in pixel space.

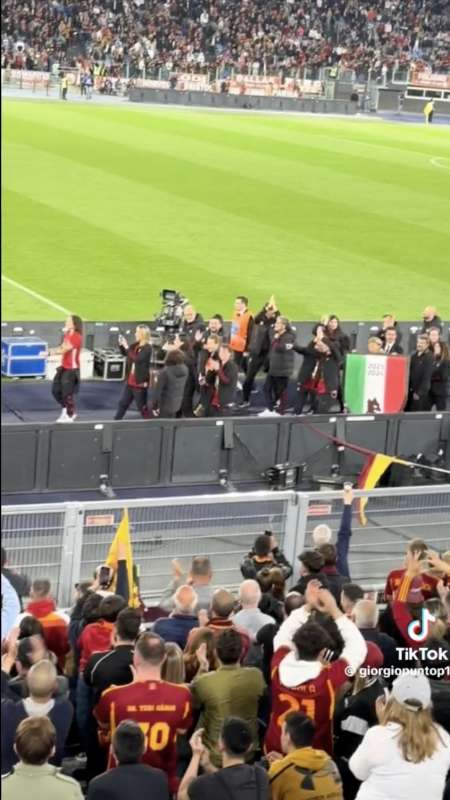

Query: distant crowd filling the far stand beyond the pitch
[2,0,450,78]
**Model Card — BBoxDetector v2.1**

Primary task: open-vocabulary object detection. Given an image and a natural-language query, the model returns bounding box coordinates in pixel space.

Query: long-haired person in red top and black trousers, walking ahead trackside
[50,314,83,422]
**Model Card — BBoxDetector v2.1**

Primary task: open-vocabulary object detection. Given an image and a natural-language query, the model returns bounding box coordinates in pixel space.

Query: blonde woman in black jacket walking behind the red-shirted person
[114,325,152,419]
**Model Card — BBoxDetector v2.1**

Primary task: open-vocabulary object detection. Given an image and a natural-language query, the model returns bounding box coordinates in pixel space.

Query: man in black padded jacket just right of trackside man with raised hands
[259,317,295,417]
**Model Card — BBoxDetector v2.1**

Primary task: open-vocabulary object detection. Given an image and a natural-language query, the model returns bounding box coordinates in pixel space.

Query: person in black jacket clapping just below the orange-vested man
[205,344,238,417]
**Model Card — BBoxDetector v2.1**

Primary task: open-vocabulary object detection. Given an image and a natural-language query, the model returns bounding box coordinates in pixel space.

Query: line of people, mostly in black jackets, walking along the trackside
[53,296,450,422]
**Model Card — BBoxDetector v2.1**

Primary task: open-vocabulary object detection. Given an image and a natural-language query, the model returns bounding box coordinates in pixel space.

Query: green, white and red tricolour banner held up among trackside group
[344,353,409,414]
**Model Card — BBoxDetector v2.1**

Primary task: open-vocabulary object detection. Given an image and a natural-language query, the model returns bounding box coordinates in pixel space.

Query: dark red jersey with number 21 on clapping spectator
[264,647,348,755]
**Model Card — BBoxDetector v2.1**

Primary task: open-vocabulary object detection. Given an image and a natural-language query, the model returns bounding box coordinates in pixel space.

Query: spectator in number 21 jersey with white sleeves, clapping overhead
[264,581,367,755]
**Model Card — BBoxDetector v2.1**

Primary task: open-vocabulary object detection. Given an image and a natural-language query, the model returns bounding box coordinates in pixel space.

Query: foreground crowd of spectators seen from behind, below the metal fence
[1,487,450,800]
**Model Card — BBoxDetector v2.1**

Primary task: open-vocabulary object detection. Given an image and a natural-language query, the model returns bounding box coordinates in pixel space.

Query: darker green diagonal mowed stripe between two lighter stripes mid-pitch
[6,115,450,277]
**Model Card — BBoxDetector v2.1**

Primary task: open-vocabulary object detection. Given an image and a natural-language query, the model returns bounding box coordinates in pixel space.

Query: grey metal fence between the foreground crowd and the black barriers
[2,485,450,606]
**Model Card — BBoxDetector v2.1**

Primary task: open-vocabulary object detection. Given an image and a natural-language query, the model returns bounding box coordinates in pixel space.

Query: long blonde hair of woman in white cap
[380,697,441,764]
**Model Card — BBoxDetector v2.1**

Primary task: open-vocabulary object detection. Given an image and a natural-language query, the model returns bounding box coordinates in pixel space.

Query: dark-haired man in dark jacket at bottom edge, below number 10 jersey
[87,720,169,800]
